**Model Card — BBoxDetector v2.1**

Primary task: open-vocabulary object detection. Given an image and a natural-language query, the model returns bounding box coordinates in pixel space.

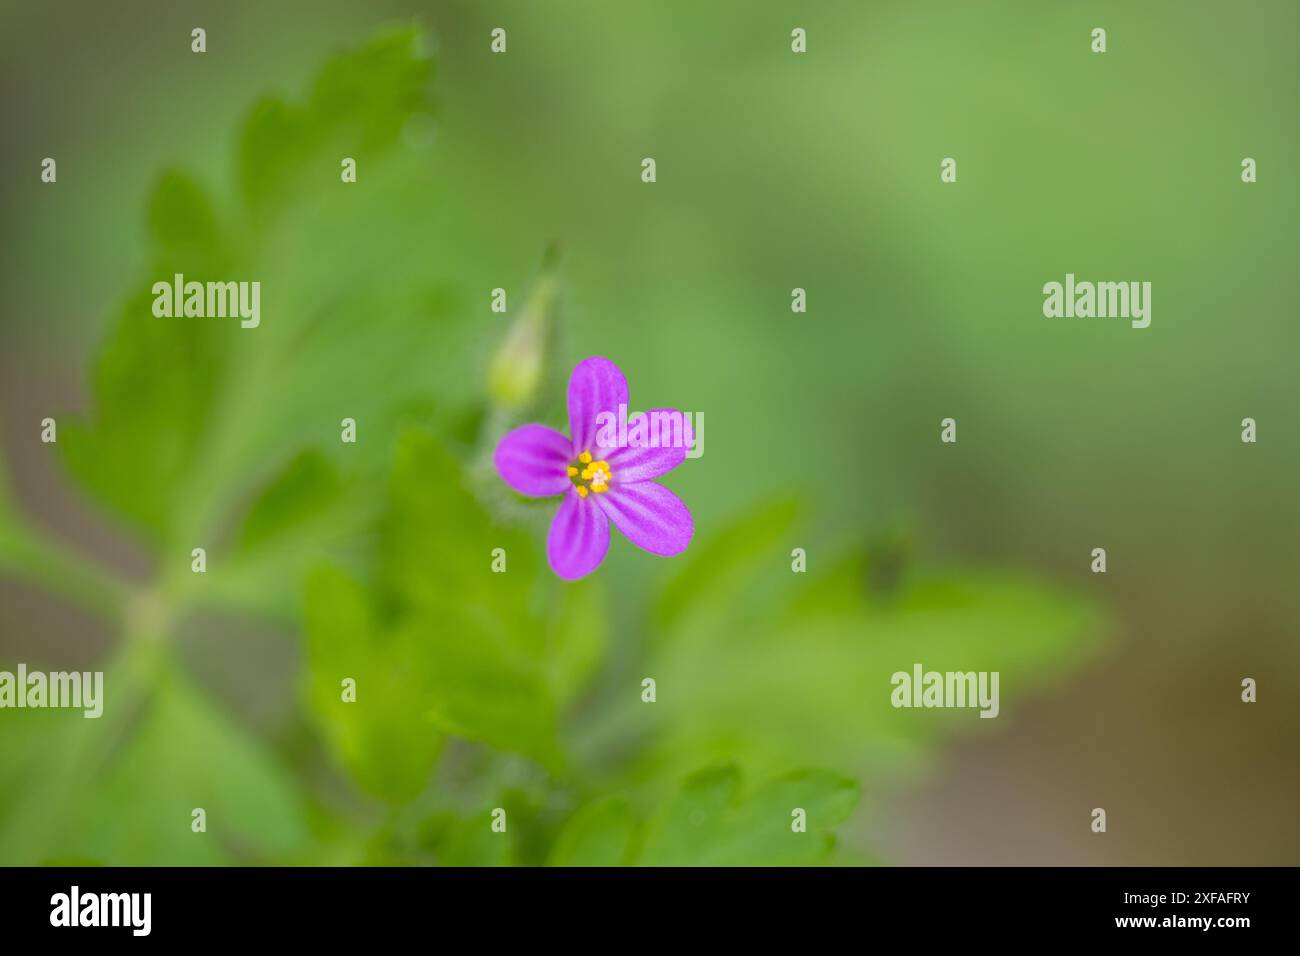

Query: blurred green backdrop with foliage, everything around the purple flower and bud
[0,0,1300,865]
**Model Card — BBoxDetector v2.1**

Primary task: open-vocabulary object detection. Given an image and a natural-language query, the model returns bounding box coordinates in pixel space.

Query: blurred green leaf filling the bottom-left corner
[0,658,307,866]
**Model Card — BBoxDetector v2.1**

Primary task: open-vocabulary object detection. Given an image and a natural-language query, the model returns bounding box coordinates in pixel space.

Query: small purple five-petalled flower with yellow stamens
[493,355,696,581]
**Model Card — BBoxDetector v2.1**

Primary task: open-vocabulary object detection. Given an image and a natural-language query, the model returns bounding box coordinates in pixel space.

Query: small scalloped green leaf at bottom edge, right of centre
[638,766,858,866]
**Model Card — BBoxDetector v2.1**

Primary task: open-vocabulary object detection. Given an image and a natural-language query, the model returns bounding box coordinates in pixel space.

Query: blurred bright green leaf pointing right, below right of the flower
[644,562,1104,773]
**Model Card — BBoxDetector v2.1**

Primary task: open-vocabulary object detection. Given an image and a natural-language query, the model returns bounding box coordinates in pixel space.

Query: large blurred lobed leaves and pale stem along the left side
[0,29,454,864]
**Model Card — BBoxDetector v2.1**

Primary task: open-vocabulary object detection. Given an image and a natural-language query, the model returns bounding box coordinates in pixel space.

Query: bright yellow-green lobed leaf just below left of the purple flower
[307,431,605,803]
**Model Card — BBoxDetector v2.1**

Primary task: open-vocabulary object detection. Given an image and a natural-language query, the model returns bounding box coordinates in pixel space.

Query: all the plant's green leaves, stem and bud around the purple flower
[0,30,1099,866]
